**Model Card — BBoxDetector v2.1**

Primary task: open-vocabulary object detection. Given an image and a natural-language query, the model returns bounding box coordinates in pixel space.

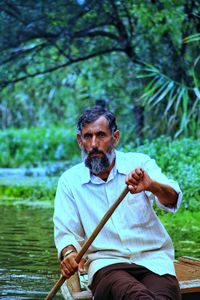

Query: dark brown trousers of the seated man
[90,263,181,300]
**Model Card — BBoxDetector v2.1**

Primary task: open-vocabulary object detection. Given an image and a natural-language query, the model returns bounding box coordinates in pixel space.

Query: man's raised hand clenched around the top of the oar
[126,168,152,194]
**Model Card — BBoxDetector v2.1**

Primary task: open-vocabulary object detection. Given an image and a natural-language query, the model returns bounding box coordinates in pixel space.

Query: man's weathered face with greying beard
[77,116,119,174]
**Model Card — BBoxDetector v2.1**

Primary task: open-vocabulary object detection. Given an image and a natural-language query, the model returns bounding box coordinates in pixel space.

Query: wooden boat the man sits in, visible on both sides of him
[61,256,200,300]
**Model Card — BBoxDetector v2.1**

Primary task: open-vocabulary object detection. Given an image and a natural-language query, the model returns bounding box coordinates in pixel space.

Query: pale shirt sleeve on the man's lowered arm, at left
[53,175,84,257]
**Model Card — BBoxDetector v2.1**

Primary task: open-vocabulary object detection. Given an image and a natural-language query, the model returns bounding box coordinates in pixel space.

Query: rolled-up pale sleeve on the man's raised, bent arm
[143,156,182,213]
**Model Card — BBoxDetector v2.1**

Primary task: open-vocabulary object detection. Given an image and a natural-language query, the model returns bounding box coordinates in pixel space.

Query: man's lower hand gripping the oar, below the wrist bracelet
[60,251,85,279]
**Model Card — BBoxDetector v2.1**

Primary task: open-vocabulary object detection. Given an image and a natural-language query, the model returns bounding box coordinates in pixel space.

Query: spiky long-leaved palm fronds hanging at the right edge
[138,65,200,138]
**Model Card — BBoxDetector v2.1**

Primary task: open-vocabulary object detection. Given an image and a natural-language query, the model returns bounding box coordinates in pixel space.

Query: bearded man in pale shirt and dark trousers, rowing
[54,107,181,300]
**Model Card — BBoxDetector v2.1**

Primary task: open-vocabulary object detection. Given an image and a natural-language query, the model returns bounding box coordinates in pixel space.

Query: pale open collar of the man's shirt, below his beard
[80,150,127,184]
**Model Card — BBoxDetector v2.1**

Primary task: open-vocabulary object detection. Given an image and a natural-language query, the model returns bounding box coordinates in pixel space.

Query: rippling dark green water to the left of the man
[0,205,62,300]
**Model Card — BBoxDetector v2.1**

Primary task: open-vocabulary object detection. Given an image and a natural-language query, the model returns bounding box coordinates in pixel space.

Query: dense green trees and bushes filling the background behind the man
[0,0,200,254]
